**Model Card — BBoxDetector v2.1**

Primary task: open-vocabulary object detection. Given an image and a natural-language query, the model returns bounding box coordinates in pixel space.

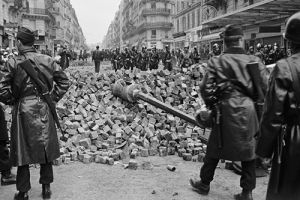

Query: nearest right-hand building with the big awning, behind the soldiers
[173,0,300,57]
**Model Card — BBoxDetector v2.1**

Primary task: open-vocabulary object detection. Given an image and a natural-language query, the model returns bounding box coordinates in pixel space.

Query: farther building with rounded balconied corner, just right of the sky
[103,0,175,49]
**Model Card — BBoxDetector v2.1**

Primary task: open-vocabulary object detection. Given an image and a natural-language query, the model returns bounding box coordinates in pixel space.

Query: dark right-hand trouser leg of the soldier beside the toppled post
[240,160,256,191]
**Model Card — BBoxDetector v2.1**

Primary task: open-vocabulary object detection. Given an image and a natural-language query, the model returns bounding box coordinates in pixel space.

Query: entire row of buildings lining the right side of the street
[103,0,300,58]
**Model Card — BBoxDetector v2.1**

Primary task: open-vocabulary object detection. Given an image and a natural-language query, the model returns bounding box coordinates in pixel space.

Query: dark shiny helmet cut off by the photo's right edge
[285,12,300,44]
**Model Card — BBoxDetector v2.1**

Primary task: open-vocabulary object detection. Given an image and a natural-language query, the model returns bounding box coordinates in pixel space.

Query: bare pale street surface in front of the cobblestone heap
[0,156,268,200]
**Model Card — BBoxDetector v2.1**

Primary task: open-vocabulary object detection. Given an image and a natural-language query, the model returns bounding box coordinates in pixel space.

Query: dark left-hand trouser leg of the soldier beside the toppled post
[200,157,219,185]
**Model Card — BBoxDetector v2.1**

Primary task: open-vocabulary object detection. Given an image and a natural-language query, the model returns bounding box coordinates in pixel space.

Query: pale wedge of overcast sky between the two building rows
[71,0,121,44]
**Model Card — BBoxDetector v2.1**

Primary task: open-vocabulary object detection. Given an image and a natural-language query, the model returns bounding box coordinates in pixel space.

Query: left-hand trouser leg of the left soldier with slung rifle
[16,165,31,192]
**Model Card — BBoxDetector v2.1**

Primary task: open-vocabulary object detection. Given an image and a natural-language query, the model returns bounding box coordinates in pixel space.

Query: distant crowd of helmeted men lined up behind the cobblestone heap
[92,38,288,72]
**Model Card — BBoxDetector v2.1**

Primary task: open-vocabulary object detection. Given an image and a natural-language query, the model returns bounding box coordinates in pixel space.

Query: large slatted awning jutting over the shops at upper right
[202,0,300,26]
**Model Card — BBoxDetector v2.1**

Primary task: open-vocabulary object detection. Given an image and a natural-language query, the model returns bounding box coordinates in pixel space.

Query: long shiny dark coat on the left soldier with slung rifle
[0,47,69,166]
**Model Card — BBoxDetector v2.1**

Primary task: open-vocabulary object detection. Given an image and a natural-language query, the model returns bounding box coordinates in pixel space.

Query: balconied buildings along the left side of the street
[0,0,87,54]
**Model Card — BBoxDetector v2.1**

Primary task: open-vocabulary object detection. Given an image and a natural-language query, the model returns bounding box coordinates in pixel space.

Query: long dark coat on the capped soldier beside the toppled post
[201,48,267,161]
